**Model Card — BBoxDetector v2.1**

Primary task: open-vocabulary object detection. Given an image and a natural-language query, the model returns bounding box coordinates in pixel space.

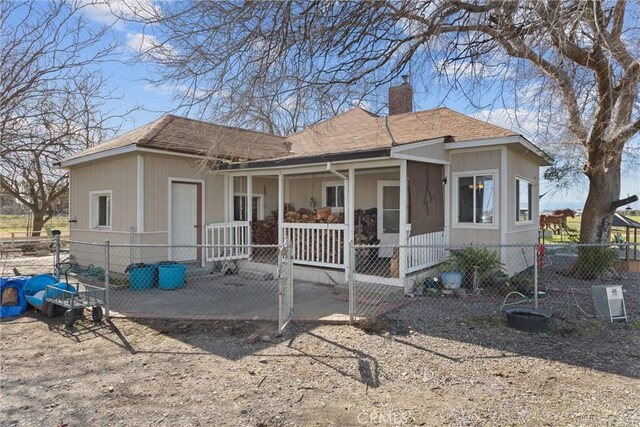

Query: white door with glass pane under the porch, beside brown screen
[378,181,400,257]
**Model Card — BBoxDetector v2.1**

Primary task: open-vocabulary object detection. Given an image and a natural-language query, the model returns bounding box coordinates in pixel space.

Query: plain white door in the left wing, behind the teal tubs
[171,182,198,261]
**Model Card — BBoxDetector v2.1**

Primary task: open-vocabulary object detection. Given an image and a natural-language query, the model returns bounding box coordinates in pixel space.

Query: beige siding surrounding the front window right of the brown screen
[447,148,504,245]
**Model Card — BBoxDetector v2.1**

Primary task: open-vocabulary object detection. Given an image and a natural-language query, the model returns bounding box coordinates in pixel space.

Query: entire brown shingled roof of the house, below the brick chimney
[65,108,518,166]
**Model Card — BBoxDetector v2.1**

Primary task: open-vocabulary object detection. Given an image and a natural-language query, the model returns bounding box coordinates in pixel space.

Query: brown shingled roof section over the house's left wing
[64,114,287,161]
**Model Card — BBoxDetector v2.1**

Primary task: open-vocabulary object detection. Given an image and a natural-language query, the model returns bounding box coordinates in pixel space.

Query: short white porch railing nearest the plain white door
[205,221,251,262]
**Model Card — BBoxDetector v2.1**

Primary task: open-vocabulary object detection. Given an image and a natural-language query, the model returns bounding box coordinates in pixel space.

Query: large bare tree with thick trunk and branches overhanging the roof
[131,0,640,247]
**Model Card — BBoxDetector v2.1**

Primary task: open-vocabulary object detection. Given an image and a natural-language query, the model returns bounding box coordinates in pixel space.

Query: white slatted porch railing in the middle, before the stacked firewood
[281,222,347,268]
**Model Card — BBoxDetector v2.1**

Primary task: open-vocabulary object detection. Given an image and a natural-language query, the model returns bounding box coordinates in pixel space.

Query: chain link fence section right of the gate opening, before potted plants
[350,244,640,325]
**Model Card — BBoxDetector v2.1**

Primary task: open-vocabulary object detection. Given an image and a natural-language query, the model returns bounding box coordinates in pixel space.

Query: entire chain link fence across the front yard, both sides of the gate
[2,239,640,328]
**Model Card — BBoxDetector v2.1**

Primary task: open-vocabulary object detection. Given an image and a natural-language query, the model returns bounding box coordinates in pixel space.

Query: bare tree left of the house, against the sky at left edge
[0,1,129,236]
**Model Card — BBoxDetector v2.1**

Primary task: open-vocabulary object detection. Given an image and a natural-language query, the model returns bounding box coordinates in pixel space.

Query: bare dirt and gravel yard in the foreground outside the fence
[0,301,640,426]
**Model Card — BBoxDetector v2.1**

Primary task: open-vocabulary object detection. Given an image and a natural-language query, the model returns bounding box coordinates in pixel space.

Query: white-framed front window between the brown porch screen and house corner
[456,172,497,226]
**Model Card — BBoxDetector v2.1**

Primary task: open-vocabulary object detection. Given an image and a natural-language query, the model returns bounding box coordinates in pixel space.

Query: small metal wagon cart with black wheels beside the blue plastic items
[46,262,106,327]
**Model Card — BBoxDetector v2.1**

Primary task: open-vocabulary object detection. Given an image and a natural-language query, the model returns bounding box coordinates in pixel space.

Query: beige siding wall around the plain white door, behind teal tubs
[144,154,225,237]
